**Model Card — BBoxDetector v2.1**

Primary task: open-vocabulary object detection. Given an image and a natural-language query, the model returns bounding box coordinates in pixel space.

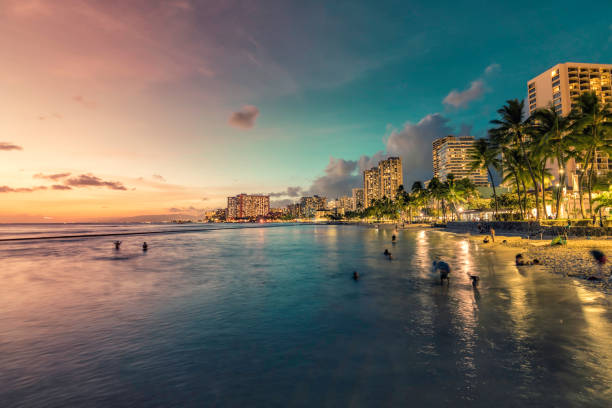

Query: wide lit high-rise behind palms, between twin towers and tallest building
[432,136,489,187]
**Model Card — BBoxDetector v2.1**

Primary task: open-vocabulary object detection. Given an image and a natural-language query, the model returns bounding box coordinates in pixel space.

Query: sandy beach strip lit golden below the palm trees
[438,229,612,294]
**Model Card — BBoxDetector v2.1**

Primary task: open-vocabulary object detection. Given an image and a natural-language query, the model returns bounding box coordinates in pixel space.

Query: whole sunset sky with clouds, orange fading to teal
[0,0,612,222]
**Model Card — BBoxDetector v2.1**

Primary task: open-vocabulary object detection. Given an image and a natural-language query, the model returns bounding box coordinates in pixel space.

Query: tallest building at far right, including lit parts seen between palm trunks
[527,62,612,186]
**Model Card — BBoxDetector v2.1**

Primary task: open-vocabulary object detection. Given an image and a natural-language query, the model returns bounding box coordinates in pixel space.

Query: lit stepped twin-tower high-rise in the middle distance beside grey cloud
[363,157,403,208]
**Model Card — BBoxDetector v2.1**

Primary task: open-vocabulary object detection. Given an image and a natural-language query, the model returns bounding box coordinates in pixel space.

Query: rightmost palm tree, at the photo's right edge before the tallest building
[570,92,612,218]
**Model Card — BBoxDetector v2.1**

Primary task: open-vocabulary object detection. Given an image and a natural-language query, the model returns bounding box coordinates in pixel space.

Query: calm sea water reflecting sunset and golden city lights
[0,225,612,407]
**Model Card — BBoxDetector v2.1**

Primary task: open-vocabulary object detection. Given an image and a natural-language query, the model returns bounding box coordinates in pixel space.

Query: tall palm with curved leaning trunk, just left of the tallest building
[489,99,540,219]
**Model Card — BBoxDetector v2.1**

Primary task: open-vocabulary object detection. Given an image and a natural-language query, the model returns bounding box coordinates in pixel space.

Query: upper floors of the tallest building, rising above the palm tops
[527,62,612,115]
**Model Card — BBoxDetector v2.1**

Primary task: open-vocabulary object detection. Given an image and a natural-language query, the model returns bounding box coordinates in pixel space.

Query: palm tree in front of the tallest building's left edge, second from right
[531,105,572,219]
